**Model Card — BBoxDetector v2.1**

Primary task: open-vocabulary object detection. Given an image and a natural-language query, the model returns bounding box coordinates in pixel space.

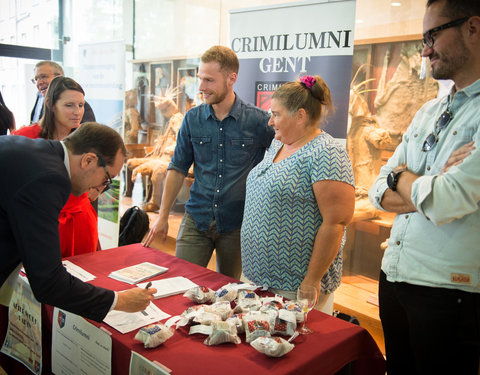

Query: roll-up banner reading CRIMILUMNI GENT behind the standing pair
[230,1,355,139]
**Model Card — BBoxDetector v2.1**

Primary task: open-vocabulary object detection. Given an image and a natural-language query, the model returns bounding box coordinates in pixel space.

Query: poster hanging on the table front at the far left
[1,276,42,374]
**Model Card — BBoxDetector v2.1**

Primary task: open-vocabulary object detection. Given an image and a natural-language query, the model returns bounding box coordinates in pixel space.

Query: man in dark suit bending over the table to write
[0,123,156,322]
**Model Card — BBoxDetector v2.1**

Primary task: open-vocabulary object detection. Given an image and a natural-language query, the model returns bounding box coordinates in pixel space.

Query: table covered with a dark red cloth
[0,244,385,375]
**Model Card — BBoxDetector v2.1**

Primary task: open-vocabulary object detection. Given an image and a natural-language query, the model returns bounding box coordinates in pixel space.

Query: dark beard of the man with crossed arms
[430,38,471,79]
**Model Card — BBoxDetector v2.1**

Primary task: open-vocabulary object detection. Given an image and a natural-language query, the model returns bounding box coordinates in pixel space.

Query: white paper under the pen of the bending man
[103,302,170,333]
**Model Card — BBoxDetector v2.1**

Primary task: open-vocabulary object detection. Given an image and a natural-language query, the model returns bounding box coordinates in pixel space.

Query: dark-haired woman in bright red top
[12,76,102,257]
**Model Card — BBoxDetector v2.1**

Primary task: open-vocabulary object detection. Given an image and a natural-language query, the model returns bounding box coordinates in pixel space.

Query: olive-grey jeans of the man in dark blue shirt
[175,212,242,280]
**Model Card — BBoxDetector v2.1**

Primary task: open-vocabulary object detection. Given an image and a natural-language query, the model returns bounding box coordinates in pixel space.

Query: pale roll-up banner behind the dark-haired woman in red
[78,41,125,249]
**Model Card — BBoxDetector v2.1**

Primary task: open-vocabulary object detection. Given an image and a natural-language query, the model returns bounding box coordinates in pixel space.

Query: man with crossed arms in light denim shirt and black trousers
[370,0,480,375]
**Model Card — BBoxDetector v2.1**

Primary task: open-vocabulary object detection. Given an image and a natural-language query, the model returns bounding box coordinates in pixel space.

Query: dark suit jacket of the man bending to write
[0,136,114,322]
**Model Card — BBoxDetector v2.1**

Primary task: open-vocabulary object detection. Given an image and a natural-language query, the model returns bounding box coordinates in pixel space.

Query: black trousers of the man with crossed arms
[378,272,480,375]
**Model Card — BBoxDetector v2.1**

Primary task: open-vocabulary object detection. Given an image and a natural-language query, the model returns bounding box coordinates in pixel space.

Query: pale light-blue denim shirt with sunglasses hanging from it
[370,80,480,293]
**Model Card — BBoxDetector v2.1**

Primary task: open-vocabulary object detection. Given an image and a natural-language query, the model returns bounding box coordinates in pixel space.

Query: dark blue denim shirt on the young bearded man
[168,96,274,233]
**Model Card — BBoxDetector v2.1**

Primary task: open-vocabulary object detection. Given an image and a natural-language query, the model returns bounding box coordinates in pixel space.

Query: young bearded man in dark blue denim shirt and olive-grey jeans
[144,46,274,279]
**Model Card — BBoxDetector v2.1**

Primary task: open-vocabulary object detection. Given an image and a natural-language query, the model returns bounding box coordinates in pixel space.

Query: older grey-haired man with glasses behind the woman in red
[30,60,95,124]
